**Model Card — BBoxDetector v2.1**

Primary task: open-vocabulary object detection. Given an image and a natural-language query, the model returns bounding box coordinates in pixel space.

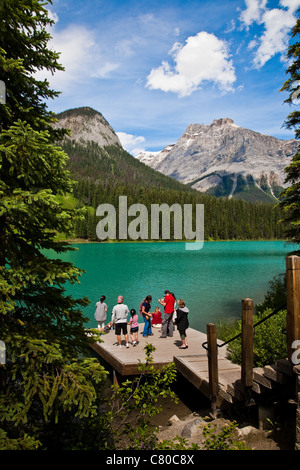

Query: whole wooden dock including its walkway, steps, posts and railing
[90,256,300,438]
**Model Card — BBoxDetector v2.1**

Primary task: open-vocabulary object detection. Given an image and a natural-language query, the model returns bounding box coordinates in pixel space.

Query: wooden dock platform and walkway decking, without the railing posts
[91,323,291,409]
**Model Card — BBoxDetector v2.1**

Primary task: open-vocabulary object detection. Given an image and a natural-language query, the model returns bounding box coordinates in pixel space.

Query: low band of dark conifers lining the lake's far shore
[74,180,283,240]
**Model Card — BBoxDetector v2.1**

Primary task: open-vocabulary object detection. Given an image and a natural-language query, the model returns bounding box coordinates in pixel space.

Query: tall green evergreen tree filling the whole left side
[0,0,106,449]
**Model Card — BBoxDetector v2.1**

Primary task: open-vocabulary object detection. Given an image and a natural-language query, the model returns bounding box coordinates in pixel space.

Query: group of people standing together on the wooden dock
[95,290,189,349]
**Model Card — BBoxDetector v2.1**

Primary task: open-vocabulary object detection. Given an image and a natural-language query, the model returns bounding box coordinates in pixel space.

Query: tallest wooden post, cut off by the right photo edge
[286,256,300,362]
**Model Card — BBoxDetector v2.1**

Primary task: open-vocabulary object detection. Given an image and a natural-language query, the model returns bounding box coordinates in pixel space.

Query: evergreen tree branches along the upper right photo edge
[280,11,300,252]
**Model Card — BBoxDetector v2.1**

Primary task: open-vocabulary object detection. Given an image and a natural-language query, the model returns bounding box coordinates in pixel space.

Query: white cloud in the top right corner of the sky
[240,0,300,68]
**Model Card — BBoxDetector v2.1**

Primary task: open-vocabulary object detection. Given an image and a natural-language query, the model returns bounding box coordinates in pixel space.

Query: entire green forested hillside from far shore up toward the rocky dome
[62,140,283,241]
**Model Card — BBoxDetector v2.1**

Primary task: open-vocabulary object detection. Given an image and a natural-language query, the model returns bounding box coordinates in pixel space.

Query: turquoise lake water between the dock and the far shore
[58,241,292,332]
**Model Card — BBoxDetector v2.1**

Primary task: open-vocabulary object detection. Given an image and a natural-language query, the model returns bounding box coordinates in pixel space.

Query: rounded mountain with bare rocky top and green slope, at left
[54,107,193,192]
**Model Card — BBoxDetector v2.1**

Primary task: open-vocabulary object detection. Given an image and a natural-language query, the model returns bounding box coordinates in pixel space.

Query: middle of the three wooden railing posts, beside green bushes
[241,299,253,387]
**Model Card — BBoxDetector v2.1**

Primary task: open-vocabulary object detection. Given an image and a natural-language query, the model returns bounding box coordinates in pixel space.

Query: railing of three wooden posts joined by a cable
[202,256,300,415]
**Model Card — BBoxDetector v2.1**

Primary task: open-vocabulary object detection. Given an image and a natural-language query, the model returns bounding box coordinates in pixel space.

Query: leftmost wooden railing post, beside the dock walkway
[206,323,219,418]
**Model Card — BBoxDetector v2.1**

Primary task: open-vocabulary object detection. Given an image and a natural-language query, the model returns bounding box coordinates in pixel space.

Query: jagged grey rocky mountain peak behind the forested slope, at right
[137,118,298,202]
